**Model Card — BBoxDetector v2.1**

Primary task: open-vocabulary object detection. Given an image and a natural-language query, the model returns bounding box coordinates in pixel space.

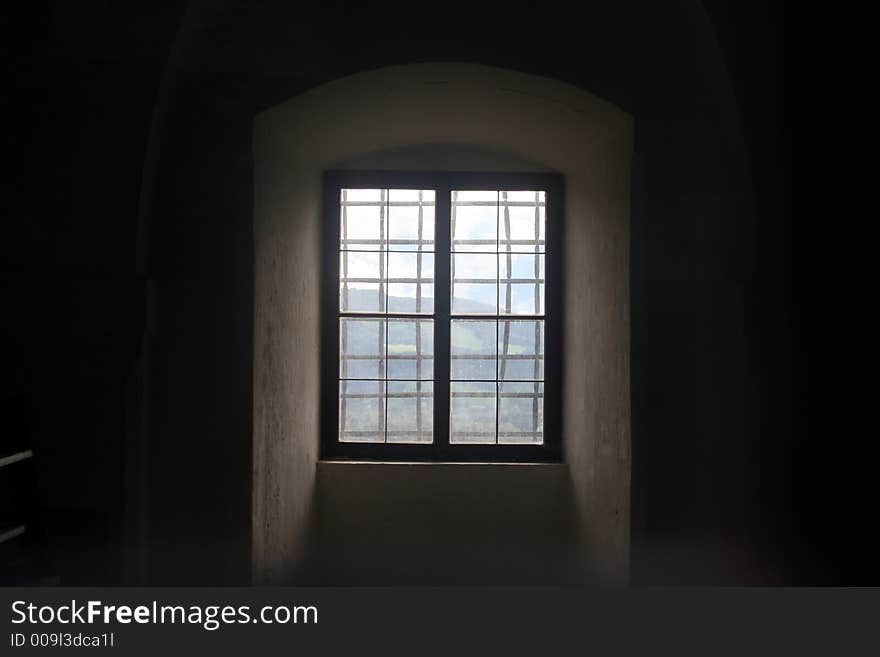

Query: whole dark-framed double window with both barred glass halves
[322,171,562,461]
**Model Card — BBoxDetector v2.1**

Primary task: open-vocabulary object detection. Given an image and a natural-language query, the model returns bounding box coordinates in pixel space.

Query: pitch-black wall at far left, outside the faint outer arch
[0,2,179,583]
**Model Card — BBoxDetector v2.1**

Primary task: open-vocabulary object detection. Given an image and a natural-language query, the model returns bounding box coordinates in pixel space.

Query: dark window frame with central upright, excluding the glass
[320,170,565,463]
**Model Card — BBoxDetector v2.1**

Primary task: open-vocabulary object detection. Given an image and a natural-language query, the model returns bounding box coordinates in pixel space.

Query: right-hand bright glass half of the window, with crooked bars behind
[449,191,546,444]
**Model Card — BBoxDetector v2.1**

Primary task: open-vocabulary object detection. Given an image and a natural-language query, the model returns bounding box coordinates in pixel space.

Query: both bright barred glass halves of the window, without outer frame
[339,189,546,445]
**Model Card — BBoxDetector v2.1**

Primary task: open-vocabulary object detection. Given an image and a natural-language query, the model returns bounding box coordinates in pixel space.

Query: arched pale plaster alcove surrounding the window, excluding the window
[253,64,633,583]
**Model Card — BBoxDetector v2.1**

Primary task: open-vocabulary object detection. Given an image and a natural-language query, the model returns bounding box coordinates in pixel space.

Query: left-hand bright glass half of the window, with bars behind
[339,189,435,443]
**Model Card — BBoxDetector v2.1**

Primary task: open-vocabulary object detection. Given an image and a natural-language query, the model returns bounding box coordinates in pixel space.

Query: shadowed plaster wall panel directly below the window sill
[309,462,585,585]
